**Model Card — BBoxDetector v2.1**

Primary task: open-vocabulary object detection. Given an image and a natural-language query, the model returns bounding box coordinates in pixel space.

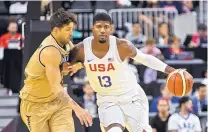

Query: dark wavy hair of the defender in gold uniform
[50,8,77,30]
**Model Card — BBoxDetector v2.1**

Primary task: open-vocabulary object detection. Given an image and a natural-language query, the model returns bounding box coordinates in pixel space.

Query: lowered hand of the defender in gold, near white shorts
[74,107,92,127]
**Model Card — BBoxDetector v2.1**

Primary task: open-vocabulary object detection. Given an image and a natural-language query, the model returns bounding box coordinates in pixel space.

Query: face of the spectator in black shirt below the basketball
[157,98,169,113]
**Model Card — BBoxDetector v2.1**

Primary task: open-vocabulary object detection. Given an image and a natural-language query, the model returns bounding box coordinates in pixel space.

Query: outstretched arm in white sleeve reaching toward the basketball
[120,40,175,74]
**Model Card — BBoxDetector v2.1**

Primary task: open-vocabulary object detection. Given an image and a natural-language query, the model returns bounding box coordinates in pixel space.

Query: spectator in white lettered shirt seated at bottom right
[168,97,201,132]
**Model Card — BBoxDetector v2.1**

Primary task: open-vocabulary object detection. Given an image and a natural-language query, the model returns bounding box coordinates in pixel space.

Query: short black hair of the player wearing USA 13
[93,12,112,24]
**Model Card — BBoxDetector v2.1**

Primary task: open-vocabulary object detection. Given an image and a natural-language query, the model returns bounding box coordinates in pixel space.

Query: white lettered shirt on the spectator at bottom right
[168,113,201,132]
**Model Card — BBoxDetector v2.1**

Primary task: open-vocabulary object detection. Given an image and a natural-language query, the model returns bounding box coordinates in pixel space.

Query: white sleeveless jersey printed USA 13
[83,36,140,95]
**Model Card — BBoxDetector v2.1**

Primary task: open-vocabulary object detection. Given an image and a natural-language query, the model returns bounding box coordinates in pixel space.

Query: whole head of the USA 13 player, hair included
[92,13,113,44]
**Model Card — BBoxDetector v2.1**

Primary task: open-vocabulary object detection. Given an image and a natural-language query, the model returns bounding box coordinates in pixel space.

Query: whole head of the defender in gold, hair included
[50,8,76,44]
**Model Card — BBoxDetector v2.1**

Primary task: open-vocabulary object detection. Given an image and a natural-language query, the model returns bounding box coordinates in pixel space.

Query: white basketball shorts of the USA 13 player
[97,88,152,132]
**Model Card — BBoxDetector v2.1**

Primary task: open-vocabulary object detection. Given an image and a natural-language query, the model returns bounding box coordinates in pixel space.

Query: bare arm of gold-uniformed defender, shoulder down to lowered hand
[40,47,92,127]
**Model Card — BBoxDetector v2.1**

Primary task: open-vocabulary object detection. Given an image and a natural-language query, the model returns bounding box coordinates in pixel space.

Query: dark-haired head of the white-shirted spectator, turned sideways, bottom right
[179,96,193,112]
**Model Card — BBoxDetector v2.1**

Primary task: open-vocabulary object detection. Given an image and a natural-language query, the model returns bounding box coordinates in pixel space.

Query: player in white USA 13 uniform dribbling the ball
[69,13,191,132]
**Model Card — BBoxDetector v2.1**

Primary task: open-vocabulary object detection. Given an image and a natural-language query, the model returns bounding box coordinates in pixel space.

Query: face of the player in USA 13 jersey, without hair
[92,21,113,43]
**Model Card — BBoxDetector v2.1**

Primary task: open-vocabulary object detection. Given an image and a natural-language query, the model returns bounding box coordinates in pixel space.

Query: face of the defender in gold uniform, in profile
[58,22,74,44]
